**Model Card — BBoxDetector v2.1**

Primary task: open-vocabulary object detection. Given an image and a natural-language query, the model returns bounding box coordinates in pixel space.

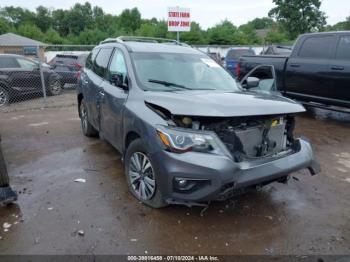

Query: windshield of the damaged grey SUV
[132,53,240,91]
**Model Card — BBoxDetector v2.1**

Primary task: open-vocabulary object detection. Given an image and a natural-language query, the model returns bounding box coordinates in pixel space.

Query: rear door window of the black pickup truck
[298,36,334,58]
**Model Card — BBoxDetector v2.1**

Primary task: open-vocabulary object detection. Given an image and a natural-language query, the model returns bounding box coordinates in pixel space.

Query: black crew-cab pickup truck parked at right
[237,31,350,108]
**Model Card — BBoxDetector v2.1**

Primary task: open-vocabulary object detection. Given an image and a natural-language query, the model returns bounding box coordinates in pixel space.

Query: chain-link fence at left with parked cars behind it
[0,45,93,112]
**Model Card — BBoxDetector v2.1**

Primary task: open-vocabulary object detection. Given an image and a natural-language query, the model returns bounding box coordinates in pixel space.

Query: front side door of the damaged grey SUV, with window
[101,48,128,151]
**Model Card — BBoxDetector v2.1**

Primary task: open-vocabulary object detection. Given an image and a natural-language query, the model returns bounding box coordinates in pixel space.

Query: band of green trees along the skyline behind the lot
[0,0,344,45]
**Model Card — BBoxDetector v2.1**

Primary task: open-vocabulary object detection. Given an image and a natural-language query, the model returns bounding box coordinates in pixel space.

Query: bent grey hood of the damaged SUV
[145,91,305,117]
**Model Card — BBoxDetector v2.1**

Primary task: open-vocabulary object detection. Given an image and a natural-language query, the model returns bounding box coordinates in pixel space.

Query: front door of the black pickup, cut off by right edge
[329,34,350,107]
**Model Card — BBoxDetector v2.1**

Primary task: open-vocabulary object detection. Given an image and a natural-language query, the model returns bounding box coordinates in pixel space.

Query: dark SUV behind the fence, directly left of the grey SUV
[49,54,88,87]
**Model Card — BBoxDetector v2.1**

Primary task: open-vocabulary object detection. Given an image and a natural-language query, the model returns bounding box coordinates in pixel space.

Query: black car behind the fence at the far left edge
[0,54,62,107]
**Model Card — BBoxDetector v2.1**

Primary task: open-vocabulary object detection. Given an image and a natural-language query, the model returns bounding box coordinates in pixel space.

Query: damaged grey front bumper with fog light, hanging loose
[151,138,320,205]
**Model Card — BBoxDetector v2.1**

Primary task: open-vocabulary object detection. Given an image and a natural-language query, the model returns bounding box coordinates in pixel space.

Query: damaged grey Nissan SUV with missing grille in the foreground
[77,37,319,208]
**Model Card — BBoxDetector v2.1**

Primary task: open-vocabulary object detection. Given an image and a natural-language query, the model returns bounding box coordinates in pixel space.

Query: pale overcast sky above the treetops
[0,0,350,29]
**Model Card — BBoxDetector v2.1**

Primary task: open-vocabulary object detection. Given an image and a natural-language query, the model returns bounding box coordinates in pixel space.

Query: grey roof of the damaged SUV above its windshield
[100,41,202,54]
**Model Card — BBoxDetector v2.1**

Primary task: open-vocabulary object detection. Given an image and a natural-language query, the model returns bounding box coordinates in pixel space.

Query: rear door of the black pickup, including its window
[286,35,336,100]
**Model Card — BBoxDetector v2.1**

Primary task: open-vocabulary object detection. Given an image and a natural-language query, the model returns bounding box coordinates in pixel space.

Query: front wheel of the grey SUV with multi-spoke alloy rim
[124,138,167,208]
